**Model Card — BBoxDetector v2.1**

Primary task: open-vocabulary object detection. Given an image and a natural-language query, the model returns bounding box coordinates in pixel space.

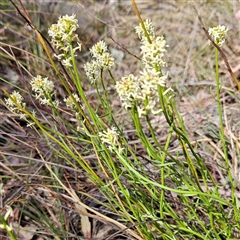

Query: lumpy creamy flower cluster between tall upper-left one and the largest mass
[84,41,114,83]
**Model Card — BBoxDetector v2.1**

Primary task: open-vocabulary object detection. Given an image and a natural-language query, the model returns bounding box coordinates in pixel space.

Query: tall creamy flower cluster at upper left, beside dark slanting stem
[48,14,81,67]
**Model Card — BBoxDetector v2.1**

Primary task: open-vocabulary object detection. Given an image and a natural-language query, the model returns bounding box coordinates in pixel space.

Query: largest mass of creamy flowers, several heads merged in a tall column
[116,20,168,117]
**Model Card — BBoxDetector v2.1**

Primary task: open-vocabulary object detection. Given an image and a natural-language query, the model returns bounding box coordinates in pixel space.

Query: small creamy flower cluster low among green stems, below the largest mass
[98,127,123,153]
